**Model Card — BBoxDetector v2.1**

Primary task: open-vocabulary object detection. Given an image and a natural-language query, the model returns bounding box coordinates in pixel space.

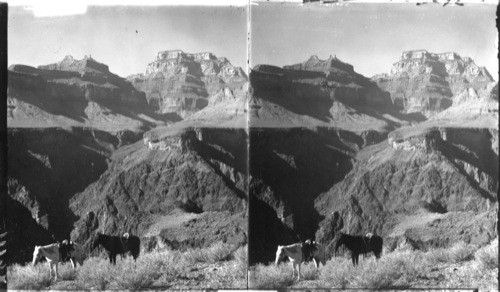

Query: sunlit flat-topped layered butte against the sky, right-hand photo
[372,50,494,117]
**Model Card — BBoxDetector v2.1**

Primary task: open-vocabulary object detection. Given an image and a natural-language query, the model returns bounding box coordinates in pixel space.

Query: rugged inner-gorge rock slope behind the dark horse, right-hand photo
[315,128,498,252]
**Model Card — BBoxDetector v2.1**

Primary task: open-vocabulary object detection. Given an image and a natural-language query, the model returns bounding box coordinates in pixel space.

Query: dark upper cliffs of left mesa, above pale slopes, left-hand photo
[8,56,146,107]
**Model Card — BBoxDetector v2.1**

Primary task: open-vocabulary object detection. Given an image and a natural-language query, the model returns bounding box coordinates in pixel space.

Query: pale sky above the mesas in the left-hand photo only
[8,6,247,77]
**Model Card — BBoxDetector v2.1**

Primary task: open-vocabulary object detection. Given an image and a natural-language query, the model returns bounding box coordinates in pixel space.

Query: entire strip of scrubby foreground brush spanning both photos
[8,239,498,290]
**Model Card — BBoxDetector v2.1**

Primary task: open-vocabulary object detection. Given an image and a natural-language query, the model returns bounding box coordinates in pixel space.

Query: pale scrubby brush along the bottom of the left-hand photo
[8,243,247,290]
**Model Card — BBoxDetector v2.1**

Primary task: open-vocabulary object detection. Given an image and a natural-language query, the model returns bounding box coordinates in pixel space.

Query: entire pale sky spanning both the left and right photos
[8,1,498,80]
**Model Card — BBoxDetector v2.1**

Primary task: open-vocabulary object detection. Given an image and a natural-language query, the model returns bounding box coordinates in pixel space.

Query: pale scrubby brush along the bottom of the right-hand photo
[249,239,498,290]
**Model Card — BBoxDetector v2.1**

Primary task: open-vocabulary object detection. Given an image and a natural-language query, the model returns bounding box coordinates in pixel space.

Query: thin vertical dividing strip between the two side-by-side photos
[245,0,252,289]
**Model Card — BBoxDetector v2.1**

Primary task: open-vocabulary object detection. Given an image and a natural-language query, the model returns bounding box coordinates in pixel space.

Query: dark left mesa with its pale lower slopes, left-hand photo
[7,56,167,132]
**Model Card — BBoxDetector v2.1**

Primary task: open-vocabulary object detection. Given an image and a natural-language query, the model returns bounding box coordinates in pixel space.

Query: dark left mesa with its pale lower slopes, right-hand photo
[249,56,410,132]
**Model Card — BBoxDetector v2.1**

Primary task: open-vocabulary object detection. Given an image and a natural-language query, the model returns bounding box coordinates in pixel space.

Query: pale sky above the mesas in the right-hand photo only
[250,3,498,80]
